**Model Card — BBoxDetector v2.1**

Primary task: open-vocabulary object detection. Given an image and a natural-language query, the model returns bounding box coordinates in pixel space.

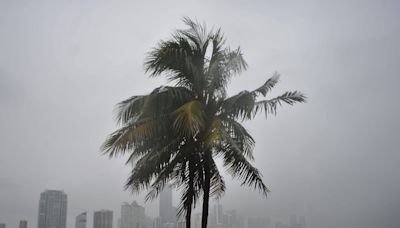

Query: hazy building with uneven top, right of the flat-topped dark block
[121,201,147,228]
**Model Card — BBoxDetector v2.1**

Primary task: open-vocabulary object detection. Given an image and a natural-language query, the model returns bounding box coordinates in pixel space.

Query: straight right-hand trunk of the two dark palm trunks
[201,151,211,228]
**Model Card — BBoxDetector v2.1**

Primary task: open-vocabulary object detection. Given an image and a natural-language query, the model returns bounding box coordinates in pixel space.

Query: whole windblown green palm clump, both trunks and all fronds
[103,18,305,228]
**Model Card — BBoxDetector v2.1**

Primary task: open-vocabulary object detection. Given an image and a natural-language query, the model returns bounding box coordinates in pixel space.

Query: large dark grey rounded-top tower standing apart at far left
[38,190,67,228]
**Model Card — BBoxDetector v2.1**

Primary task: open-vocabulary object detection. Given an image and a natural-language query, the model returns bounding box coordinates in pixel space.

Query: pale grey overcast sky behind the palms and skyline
[0,0,400,228]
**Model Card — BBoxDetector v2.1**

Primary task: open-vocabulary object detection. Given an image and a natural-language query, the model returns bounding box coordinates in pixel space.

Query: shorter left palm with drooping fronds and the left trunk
[102,87,211,227]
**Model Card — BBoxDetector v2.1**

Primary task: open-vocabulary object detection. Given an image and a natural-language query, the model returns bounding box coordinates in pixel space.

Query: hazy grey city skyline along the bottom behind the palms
[0,188,306,228]
